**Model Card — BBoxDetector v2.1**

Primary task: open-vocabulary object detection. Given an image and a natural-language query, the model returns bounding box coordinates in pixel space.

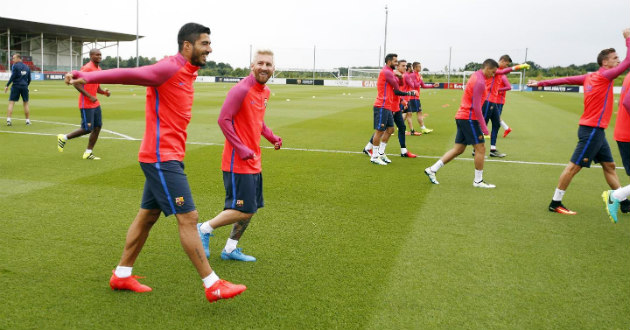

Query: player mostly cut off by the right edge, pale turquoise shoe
[602,74,630,223]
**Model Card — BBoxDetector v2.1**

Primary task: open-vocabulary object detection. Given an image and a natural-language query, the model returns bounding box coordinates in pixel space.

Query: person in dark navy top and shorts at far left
[4,54,31,126]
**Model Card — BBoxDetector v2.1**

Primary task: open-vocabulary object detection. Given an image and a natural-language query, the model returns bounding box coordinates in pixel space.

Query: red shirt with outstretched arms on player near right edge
[538,38,630,128]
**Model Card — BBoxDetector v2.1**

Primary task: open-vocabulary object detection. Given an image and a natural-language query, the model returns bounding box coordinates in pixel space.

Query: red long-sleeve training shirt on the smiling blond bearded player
[218,74,280,174]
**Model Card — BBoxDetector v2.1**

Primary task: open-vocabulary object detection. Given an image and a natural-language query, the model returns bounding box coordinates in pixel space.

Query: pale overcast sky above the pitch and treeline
[0,0,630,71]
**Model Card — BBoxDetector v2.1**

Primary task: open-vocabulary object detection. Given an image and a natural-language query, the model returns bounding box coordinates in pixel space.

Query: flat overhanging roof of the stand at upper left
[0,17,143,42]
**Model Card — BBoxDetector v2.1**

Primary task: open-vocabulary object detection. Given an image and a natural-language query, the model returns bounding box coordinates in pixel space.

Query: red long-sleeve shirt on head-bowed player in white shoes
[455,70,492,135]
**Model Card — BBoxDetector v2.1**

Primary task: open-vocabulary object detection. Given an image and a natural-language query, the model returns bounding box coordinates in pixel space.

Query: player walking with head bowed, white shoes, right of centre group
[424,59,499,188]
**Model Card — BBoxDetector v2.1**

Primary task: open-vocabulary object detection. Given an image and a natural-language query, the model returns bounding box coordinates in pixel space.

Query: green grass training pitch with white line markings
[0,82,630,330]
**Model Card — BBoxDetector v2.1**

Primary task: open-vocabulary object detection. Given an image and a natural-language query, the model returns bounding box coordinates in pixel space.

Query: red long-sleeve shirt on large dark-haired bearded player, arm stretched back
[72,53,199,163]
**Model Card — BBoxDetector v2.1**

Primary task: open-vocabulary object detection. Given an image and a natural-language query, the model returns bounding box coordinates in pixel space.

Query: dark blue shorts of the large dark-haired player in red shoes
[140,160,196,217]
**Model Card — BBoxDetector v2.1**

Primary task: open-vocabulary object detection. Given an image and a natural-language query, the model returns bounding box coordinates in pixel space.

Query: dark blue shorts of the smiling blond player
[223,171,265,213]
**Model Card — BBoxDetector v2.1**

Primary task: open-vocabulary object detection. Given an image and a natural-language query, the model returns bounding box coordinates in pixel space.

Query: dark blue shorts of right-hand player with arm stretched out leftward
[571,125,614,167]
